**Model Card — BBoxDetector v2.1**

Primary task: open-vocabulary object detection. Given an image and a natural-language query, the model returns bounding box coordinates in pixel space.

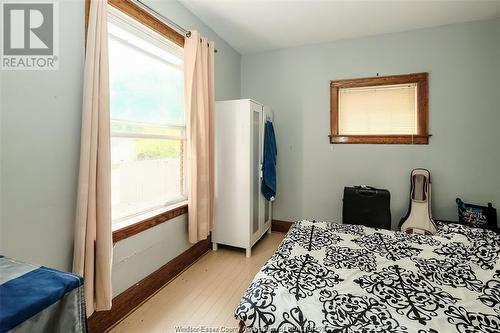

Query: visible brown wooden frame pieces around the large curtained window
[85,0,188,243]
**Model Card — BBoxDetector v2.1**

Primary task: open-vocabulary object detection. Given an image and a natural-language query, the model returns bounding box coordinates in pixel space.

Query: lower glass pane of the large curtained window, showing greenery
[111,138,184,220]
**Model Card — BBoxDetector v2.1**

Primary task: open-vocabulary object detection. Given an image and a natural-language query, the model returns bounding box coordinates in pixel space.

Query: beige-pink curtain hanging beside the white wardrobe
[184,31,215,243]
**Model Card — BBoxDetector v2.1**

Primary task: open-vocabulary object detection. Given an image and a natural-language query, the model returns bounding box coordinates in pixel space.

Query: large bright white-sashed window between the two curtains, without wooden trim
[108,7,187,225]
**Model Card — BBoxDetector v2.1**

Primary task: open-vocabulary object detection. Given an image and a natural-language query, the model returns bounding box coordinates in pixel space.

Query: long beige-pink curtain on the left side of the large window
[73,0,113,316]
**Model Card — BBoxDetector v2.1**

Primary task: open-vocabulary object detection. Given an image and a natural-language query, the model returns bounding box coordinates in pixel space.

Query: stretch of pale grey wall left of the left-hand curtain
[0,1,84,270]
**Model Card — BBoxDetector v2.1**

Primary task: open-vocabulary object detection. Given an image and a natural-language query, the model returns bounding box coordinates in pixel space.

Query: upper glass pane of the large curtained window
[109,23,184,126]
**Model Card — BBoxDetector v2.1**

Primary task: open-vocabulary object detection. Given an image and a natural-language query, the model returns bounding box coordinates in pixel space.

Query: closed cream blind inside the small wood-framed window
[338,83,417,135]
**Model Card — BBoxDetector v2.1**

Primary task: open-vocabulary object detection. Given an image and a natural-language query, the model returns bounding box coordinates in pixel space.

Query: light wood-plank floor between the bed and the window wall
[111,232,285,333]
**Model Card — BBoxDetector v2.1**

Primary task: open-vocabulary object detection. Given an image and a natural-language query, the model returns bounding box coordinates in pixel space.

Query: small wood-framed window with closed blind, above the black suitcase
[330,73,429,144]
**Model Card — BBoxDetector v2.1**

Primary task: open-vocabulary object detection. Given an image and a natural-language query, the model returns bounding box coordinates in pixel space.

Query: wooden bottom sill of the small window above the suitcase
[330,135,430,145]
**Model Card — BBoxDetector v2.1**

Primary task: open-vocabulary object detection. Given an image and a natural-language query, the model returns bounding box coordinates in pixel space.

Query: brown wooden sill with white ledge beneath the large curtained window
[113,200,188,243]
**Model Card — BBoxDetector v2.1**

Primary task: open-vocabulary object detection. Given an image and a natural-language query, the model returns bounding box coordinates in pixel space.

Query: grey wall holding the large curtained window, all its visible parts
[0,0,241,294]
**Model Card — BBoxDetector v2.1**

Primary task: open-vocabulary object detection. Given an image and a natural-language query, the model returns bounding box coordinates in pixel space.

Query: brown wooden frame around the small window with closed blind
[329,73,430,145]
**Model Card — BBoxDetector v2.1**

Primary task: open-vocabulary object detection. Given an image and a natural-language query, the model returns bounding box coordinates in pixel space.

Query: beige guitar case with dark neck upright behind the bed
[401,169,437,235]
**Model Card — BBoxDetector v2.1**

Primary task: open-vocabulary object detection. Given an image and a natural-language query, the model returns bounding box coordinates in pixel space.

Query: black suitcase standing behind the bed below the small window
[342,186,391,229]
